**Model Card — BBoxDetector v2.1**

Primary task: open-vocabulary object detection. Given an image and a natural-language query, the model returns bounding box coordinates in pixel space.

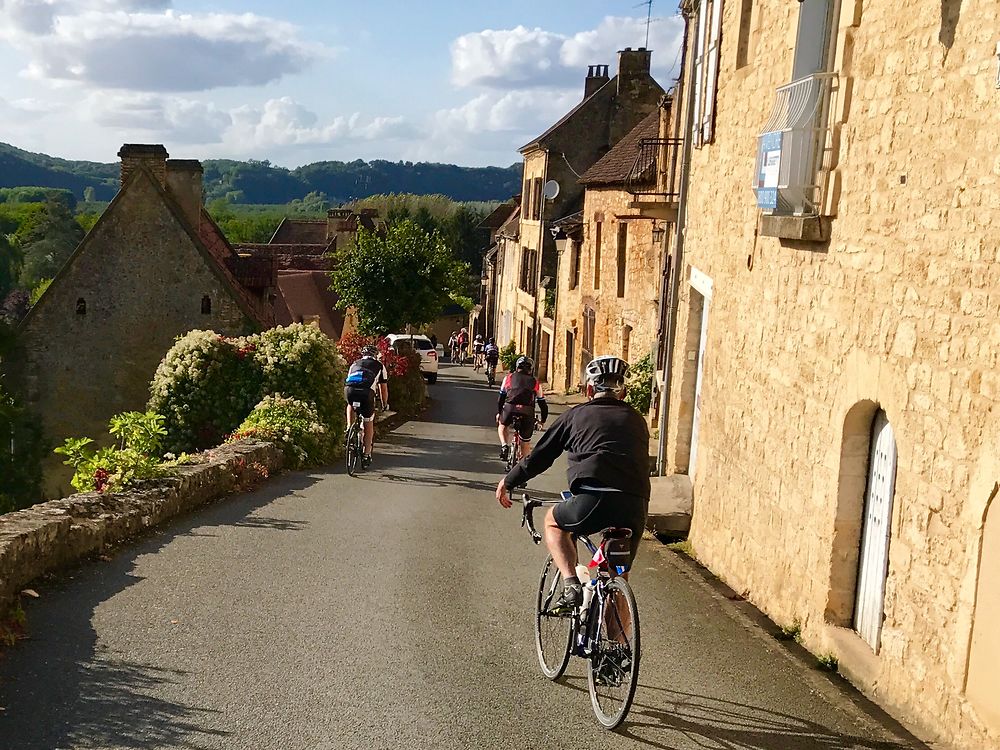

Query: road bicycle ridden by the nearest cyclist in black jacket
[521,492,641,729]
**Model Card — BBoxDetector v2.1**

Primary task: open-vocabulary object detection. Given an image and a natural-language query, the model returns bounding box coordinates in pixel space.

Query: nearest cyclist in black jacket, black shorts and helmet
[496,357,649,611]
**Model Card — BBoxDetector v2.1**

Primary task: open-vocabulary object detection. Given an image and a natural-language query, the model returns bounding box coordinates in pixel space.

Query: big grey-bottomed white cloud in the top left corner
[0,0,329,91]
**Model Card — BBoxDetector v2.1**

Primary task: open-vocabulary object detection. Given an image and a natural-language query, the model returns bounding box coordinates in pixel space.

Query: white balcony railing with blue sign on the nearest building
[753,73,837,216]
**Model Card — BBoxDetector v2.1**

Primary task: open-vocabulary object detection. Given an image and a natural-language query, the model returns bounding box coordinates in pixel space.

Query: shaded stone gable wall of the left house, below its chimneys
[5,170,253,497]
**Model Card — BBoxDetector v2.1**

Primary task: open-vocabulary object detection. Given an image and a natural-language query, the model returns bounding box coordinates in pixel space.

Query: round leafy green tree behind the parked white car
[330,220,468,334]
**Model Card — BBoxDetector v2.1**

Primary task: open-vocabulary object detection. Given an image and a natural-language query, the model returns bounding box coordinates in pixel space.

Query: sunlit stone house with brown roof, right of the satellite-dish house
[549,107,669,396]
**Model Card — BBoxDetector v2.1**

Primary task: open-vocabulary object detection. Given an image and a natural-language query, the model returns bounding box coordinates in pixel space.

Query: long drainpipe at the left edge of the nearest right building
[656,2,697,476]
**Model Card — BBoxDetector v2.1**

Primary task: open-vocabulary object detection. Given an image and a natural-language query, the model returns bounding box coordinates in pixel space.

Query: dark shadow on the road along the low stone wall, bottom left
[0,473,318,750]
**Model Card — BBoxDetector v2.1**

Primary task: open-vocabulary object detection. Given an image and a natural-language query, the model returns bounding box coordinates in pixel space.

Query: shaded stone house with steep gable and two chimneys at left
[5,144,274,494]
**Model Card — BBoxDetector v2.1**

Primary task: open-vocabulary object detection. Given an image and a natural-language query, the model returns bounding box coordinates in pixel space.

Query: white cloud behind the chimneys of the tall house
[451,16,684,89]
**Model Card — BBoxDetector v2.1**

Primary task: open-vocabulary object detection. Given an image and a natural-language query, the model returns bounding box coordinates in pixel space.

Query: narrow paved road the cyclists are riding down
[0,367,915,750]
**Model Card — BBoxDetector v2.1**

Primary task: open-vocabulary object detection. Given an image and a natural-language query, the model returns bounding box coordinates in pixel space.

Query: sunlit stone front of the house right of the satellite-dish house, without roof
[549,188,662,390]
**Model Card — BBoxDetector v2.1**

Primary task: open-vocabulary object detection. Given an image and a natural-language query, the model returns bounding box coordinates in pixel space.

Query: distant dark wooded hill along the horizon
[0,143,521,204]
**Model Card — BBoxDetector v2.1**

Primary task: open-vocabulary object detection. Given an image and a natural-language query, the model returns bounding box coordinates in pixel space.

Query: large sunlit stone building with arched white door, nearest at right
[640,0,1000,749]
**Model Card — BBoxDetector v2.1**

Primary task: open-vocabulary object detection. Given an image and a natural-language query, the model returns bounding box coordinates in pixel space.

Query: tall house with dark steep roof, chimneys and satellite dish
[496,48,663,376]
